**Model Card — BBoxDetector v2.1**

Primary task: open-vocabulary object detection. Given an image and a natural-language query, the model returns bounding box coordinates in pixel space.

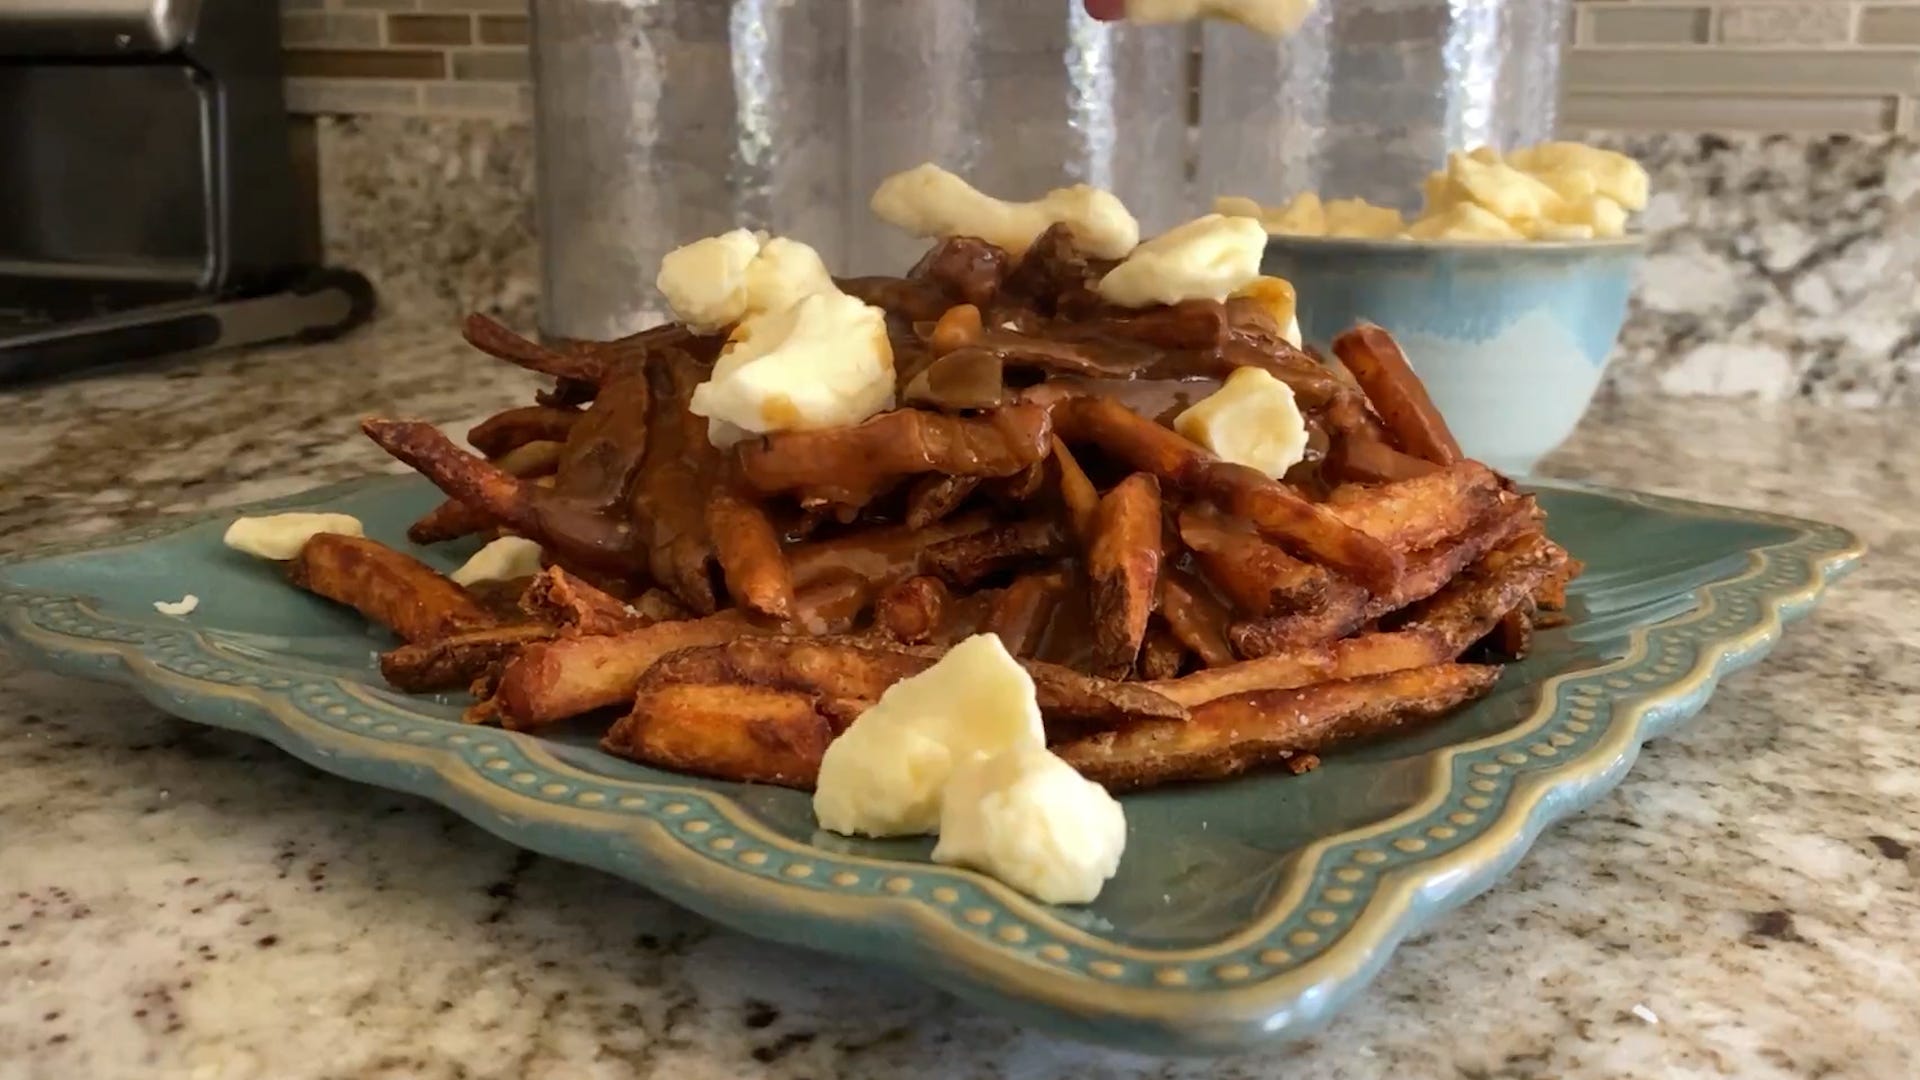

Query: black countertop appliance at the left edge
[0,0,372,380]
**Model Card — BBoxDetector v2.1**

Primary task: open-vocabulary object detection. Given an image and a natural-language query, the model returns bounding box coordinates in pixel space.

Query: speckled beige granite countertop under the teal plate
[0,329,1920,1080]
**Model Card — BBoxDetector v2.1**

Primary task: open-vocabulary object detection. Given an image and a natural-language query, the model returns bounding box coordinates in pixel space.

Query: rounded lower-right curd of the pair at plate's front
[933,746,1127,903]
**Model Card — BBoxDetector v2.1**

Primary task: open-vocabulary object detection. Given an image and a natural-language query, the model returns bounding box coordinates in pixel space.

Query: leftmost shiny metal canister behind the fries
[532,0,852,338]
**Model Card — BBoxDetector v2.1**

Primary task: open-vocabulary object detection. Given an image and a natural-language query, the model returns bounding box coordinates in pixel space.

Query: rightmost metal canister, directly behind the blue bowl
[1196,0,1571,211]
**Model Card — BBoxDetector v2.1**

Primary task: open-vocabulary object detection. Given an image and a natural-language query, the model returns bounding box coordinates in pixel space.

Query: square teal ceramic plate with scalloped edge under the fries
[0,477,1860,1053]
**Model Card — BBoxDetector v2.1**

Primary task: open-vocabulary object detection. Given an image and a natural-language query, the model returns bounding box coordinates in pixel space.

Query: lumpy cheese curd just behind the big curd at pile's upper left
[655,229,835,334]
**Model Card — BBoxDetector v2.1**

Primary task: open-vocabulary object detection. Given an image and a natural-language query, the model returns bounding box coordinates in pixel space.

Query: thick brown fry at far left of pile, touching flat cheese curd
[286,532,493,642]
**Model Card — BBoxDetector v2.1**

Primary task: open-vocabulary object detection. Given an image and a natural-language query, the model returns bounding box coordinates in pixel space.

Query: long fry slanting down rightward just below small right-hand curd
[1054,398,1402,592]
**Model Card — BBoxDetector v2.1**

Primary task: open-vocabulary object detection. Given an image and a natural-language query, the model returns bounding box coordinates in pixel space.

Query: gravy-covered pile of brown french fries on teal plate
[292,229,1578,790]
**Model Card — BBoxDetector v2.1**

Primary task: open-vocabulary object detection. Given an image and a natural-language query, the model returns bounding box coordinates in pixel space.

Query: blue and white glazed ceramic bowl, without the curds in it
[1263,236,1644,475]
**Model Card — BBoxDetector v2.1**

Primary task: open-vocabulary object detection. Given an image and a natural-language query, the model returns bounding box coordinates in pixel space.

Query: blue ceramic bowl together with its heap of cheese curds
[1215,142,1647,473]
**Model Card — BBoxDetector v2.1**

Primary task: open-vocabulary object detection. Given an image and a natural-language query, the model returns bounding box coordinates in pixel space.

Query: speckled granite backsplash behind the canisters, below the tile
[321,117,1920,405]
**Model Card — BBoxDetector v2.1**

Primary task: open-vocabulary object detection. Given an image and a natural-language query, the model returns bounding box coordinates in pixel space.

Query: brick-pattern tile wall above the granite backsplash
[280,0,1920,131]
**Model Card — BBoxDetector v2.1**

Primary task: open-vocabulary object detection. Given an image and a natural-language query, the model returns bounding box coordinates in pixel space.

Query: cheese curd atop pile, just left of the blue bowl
[1094,213,1267,307]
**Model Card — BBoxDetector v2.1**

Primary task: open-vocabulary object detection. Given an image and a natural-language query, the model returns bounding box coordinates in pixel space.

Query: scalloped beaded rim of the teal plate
[0,475,1864,1053]
